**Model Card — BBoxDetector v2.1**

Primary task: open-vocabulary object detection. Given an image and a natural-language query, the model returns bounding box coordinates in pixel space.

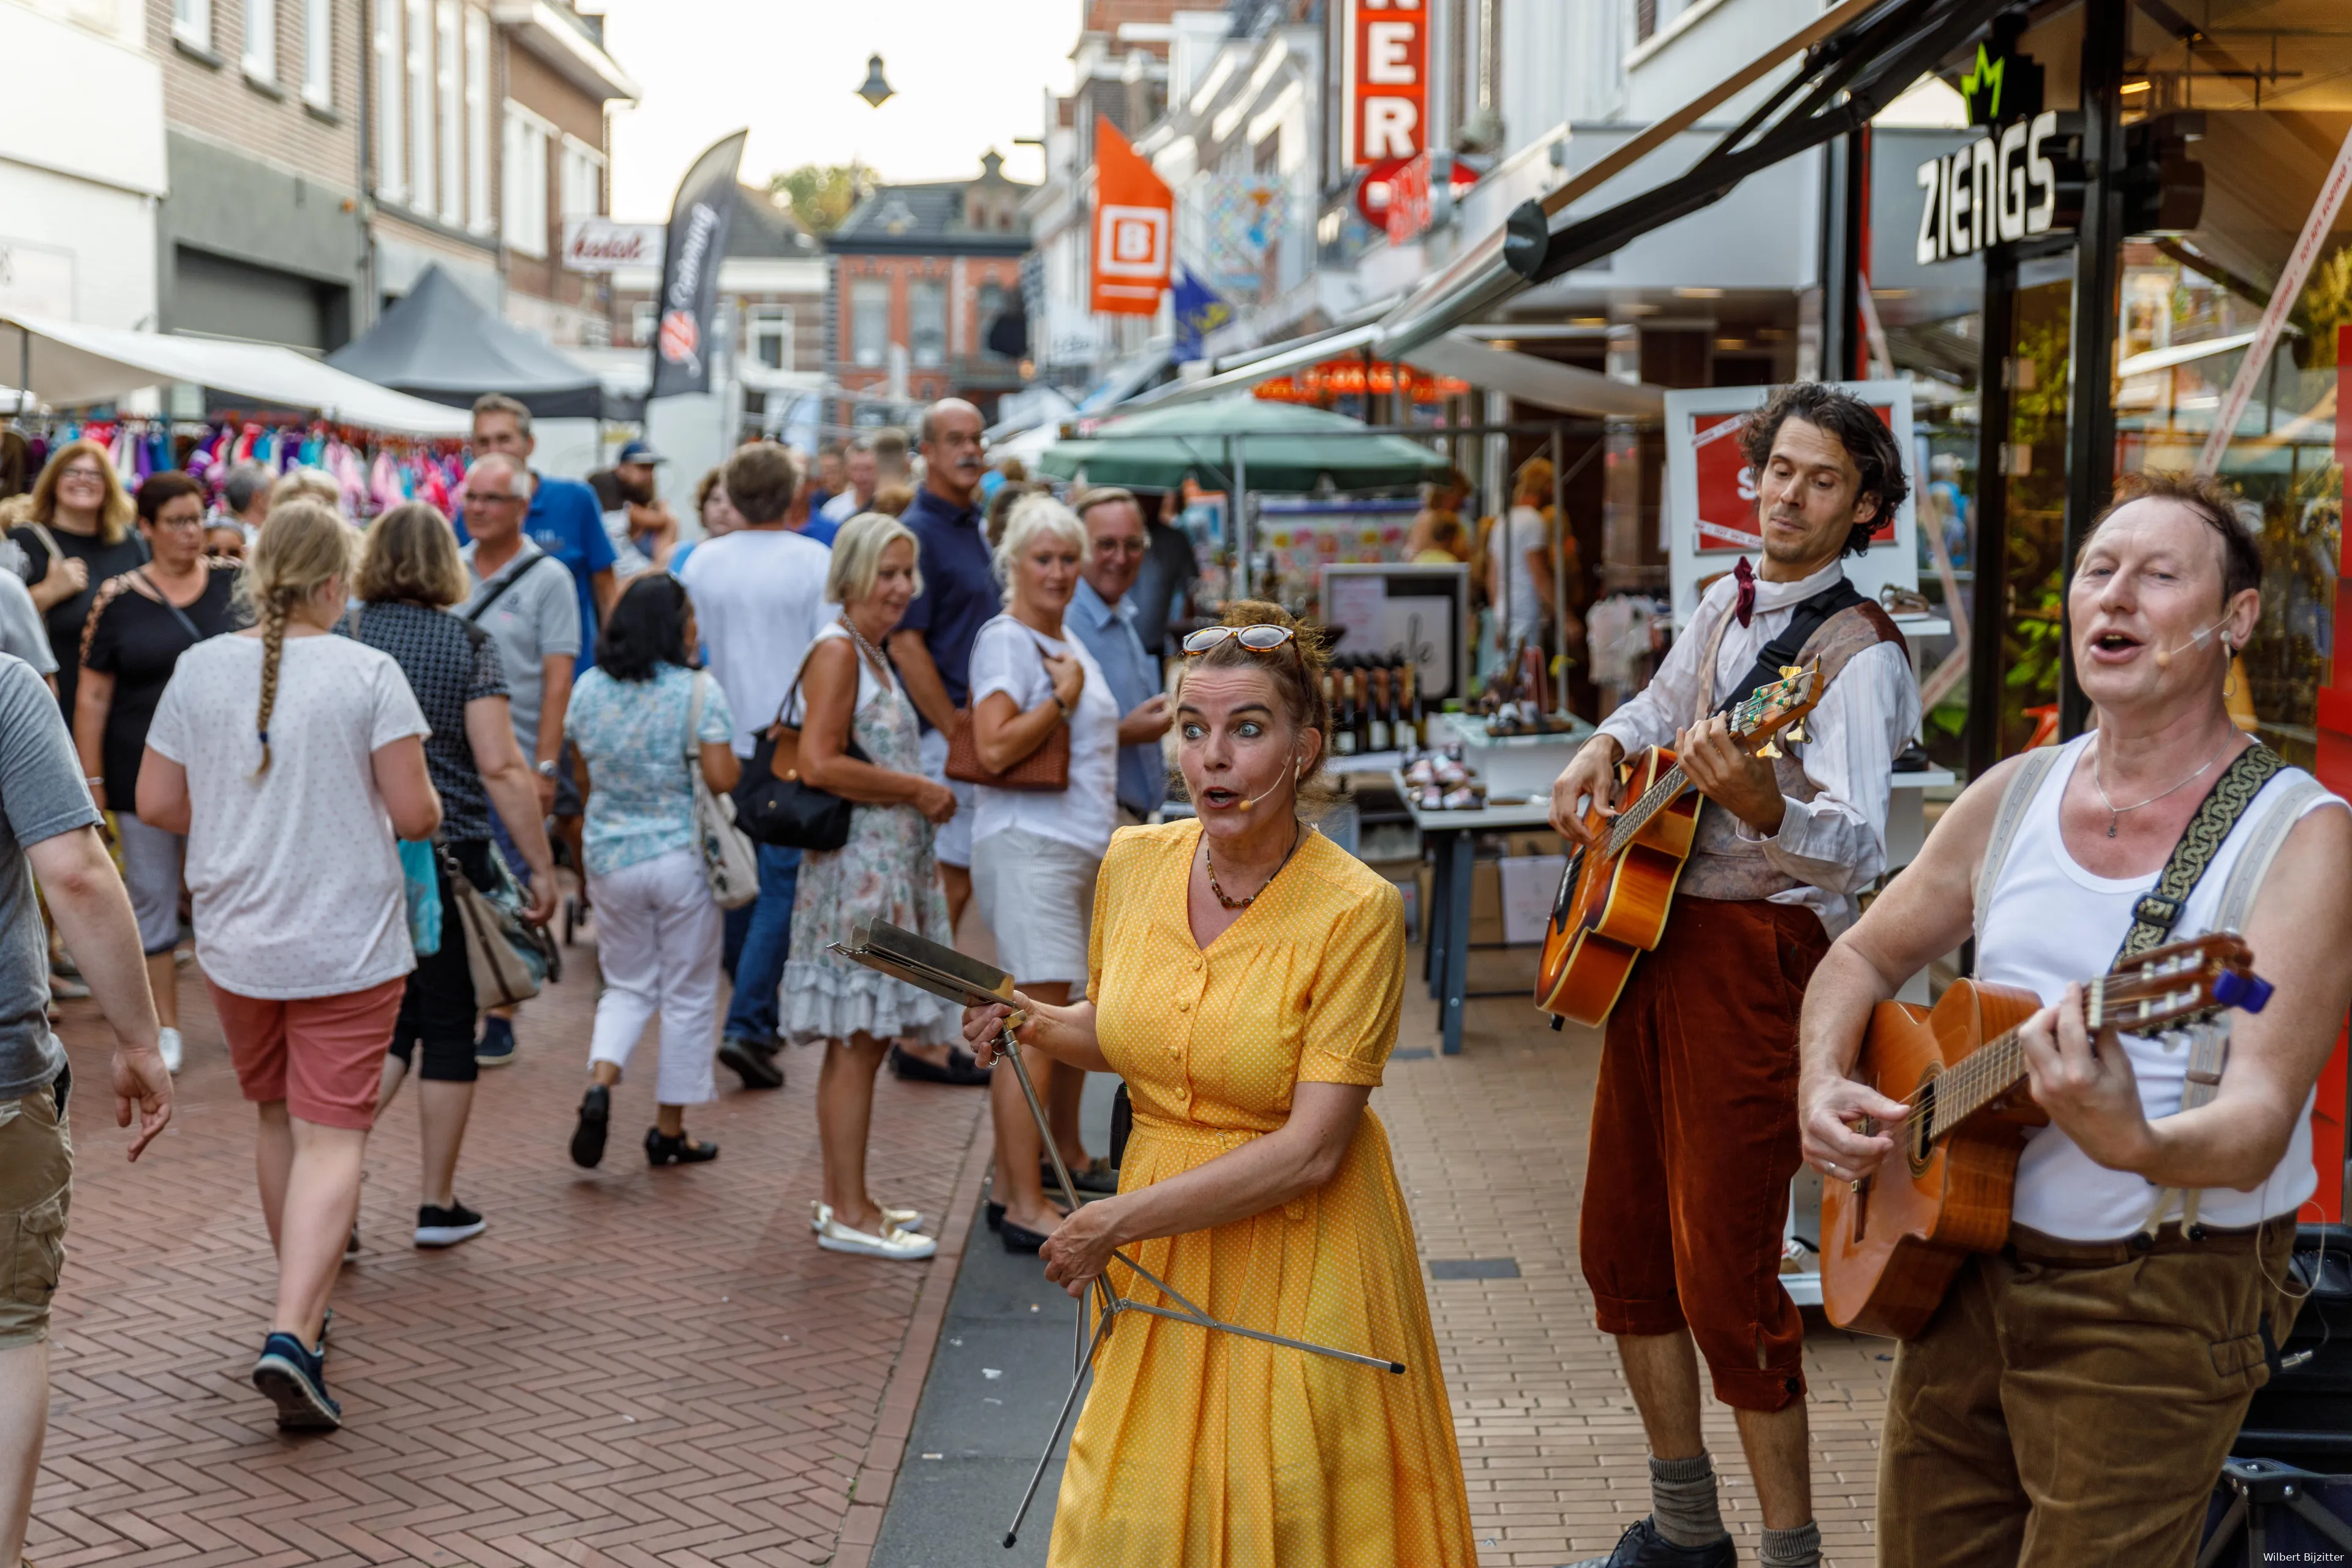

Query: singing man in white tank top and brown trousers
[1800,475,2352,1568]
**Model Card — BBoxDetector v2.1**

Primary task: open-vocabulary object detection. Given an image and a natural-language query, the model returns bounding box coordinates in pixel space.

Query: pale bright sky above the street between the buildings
[602,0,1080,224]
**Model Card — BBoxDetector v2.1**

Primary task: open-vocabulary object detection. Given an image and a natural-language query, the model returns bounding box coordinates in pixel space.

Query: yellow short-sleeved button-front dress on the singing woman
[1051,823,1477,1568]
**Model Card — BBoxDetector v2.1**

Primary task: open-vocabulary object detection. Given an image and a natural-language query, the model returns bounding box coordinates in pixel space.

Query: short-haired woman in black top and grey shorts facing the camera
[73,470,238,1072]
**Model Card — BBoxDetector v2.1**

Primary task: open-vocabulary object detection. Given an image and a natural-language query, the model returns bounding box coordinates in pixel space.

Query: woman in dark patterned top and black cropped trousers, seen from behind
[344,501,555,1246]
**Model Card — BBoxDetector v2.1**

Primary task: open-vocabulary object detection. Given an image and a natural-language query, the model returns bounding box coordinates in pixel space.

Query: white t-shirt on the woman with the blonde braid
[148,637,431,1001]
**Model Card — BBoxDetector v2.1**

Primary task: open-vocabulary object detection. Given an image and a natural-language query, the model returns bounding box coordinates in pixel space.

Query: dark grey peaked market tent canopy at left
[327,266,644,418]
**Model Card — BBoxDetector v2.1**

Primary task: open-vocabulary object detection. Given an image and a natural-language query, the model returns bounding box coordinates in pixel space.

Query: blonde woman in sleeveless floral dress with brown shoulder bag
[783,513,957,1257]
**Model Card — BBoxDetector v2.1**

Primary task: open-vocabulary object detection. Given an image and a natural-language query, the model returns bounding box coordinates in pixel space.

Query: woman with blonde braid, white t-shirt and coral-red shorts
[139,499,442,1431]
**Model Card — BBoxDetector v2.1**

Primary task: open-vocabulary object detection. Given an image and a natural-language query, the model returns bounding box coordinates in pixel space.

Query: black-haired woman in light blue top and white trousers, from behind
[565,571,741,1169]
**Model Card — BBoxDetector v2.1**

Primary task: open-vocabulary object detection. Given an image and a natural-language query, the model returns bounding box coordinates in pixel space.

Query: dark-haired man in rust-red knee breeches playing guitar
[1552,383,1919,1568]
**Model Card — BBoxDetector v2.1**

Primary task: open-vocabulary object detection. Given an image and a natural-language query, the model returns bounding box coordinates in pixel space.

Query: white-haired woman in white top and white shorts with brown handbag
[969,494,1120,1253]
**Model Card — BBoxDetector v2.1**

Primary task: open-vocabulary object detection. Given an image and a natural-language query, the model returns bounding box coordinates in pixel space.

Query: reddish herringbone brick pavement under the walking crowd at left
[28,940,986,1568]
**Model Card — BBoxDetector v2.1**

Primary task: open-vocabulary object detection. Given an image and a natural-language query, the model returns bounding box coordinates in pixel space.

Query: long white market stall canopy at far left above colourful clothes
[0,315,468,435]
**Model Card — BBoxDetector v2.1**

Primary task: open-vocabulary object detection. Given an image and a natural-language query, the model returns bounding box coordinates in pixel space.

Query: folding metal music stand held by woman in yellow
[826,922,1404,1547]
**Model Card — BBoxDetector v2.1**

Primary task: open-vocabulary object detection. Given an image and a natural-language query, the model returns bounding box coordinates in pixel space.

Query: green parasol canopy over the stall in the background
[1039,398,1449,491]
